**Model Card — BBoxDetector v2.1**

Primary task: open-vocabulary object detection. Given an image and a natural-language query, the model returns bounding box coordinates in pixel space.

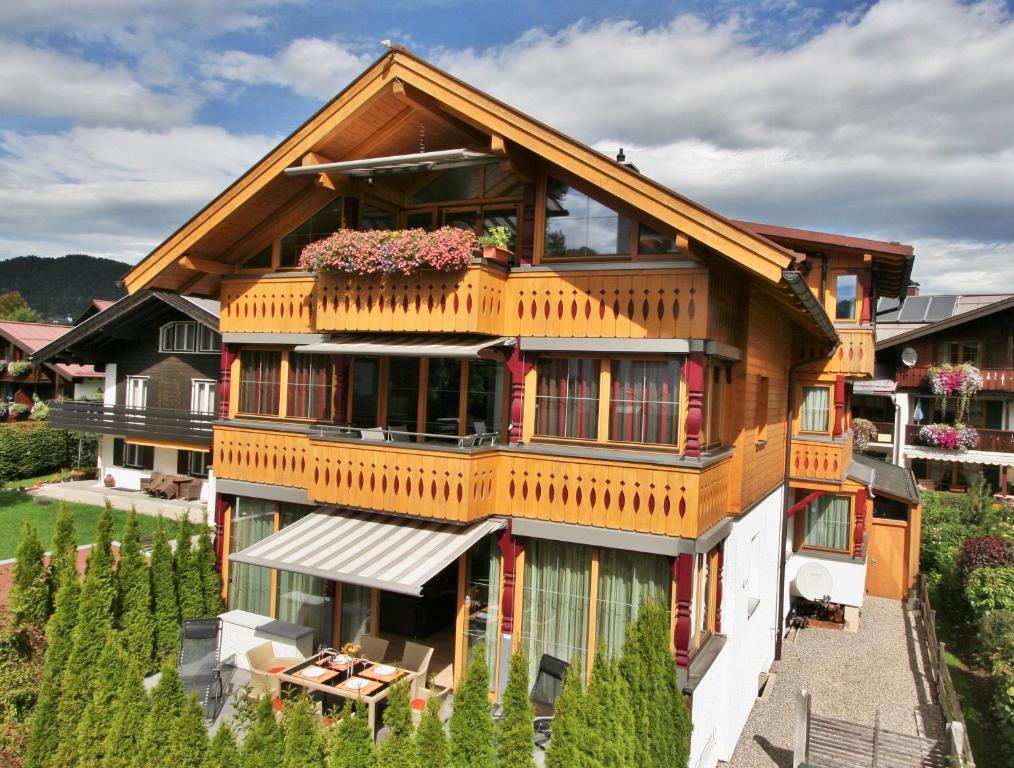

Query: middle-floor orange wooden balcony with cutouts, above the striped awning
[214,425,730,538]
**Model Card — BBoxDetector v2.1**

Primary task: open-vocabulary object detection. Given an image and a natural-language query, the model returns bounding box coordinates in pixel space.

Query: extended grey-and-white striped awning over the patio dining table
[229,508,506,596]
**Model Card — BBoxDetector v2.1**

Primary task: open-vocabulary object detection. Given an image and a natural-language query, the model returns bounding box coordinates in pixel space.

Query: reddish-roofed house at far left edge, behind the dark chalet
[0,320,102,406]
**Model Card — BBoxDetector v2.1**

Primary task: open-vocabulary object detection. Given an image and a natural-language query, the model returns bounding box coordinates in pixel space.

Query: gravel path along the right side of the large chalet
[730,597,944,768]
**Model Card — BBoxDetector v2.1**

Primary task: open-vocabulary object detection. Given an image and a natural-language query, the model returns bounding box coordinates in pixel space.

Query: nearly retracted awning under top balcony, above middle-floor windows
[296,334,516,359]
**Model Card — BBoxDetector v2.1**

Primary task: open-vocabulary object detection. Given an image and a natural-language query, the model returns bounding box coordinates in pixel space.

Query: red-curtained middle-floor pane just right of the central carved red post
[535,358,598,440]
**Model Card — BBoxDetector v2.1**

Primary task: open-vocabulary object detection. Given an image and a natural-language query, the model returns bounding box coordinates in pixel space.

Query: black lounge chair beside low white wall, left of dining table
[176,617,235,722]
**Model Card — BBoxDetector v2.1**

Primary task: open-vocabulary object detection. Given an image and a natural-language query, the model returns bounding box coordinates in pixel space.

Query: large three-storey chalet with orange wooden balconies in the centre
[115,49,912,768]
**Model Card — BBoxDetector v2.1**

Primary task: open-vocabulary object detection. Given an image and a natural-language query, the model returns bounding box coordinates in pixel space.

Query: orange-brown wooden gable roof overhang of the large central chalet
[124,47,823,334]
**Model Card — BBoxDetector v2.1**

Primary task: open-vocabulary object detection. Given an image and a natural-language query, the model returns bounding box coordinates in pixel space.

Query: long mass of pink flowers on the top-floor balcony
[299,226,479,275]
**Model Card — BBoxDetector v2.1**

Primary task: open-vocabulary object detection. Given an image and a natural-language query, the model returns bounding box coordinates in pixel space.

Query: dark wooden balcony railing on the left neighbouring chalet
[49,400,217,445]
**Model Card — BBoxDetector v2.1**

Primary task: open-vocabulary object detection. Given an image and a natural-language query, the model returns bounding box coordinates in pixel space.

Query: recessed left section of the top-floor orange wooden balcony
[219,275,317,334]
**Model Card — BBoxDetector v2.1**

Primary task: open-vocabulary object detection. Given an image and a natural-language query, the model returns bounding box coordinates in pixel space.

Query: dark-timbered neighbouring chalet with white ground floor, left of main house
[34,291,221,499]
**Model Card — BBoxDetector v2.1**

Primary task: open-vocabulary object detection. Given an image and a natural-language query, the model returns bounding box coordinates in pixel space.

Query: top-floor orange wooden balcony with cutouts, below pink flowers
[220,263,708,339]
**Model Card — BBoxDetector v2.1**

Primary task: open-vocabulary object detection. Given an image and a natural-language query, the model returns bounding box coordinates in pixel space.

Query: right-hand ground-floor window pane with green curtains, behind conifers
[595,549,672,658]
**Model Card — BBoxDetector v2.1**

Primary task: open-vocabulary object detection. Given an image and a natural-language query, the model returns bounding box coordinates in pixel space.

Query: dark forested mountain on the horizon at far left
[0,254,131,323]
